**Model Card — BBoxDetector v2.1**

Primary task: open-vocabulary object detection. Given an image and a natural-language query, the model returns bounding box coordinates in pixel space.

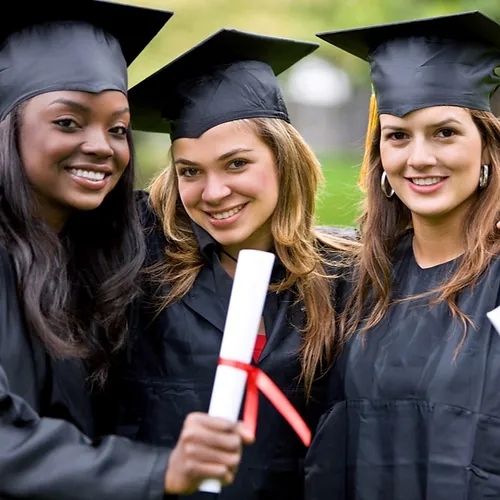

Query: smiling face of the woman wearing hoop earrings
[380,106,489,225]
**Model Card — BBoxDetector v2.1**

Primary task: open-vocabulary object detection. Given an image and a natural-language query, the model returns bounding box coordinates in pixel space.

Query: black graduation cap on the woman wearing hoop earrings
[317,11,500,117]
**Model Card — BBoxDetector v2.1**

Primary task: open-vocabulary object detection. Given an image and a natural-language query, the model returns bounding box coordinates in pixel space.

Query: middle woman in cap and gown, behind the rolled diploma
[112,29,356,500]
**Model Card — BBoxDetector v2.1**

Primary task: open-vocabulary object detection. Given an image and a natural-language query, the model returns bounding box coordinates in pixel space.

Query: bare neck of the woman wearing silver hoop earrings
[412,203,465,268]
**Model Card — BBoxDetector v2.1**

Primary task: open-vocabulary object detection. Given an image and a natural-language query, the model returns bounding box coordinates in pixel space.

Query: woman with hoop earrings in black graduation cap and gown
[306,12,500,500]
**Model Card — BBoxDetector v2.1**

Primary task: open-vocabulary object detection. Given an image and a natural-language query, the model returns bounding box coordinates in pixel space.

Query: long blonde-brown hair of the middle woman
[150,118,355,394]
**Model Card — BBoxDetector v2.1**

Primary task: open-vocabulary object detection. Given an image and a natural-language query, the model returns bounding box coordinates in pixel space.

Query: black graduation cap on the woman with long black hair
[0,0,173,120]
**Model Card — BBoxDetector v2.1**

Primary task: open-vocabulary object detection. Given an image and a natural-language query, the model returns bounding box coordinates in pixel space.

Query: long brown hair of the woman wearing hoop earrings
[341,110,500,347]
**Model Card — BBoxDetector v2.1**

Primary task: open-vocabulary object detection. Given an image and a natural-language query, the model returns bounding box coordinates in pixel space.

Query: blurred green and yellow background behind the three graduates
[121,0,500,226]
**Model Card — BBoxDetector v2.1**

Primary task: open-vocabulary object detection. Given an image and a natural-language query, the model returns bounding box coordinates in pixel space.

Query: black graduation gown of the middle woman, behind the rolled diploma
[113,194,322,500]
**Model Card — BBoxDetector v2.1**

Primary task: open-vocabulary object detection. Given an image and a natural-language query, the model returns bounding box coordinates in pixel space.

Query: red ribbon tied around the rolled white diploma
[218,358,311,446]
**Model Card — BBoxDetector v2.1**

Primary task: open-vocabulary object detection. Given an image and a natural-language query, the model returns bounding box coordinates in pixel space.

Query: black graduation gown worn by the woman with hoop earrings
[306,235,500,500]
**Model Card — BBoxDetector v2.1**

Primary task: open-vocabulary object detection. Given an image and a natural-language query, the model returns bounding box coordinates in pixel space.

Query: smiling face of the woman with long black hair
[19,91,130,229]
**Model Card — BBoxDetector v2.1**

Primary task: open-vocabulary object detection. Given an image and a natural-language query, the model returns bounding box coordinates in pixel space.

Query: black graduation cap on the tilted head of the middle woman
[129,28,319,140]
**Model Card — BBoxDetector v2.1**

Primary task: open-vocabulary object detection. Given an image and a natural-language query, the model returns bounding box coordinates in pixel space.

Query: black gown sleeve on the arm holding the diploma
[0,249,170,500]
